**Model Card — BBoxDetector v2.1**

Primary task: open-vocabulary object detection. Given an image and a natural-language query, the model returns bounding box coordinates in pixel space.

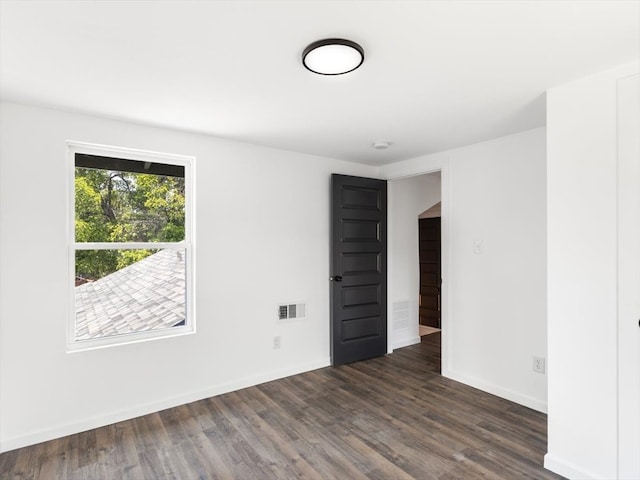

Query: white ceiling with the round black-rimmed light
[0,0,640,165]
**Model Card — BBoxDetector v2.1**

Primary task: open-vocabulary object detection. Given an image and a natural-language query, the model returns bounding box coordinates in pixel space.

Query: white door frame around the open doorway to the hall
[384,161,453,377]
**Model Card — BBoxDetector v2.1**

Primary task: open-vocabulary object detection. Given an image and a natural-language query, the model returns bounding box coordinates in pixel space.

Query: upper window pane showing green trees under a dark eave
[75,161,185,242]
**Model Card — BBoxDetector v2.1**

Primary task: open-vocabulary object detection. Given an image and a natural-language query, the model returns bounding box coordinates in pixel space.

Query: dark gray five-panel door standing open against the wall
[331,174,387,365]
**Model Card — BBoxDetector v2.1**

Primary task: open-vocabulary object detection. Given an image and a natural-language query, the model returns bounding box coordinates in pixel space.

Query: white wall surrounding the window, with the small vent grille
[0,104,376,451]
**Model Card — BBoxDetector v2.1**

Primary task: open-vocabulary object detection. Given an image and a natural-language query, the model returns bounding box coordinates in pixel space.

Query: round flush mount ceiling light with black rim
[302,38,364,75]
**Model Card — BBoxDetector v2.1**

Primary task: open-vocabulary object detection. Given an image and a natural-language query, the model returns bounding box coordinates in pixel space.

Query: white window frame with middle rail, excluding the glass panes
[67,141,196,353]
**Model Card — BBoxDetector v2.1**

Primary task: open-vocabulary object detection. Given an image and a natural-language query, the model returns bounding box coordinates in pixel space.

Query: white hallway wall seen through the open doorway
[387,174,440,348]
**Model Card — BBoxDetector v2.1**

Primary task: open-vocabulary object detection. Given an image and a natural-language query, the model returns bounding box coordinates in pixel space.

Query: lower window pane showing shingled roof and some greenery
[75,249,186,340]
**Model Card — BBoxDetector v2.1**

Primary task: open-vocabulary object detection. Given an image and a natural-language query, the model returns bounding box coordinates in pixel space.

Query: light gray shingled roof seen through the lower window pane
[75,250,185,340]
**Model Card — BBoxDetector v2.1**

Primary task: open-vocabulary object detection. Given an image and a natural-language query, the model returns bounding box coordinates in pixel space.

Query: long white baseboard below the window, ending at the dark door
[0,358,331,453]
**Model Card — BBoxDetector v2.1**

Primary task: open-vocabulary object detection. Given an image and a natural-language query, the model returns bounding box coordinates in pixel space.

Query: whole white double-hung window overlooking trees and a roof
[68,142,195,350]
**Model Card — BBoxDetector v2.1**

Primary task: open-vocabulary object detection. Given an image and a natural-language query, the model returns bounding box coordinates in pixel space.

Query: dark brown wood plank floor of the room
[0,333,562,480]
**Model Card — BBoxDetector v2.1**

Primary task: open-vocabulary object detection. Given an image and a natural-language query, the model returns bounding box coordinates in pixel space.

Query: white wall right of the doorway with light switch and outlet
[380,128,547,411]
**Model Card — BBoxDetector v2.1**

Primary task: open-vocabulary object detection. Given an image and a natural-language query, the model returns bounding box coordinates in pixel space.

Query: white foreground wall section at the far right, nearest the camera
[545,63,640,479]
